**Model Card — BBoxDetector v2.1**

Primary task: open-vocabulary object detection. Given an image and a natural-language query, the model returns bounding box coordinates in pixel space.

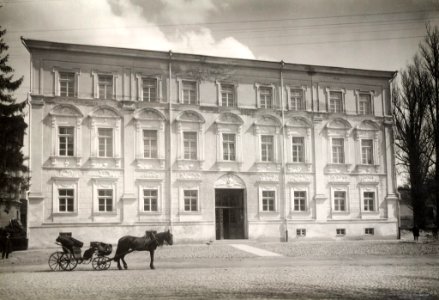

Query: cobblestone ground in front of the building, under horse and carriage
[0,241,439,299]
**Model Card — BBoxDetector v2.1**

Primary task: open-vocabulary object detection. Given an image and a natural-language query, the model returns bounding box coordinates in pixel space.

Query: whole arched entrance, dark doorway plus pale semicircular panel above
[215,174,247,240]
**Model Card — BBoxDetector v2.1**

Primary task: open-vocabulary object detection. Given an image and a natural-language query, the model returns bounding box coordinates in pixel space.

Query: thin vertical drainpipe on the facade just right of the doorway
[280,60,288,242]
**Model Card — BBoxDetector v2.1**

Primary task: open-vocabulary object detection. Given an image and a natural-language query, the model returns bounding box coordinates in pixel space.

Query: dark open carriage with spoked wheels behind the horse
[49,235,112,271]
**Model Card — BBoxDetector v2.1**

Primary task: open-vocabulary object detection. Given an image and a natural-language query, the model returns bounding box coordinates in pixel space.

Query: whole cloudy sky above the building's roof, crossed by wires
[0,0,439,100]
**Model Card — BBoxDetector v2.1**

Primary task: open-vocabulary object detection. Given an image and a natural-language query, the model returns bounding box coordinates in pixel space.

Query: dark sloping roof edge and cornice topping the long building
[21,37,397,80]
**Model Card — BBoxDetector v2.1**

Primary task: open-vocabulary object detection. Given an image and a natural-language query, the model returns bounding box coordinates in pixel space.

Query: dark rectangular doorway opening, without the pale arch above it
[215,189,245,240]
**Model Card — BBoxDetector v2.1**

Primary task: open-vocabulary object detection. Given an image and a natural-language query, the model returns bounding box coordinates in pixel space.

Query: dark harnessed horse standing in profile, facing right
[113,230,173,270]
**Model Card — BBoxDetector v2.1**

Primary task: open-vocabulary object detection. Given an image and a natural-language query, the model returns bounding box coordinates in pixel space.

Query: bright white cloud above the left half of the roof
[4,0,254,58]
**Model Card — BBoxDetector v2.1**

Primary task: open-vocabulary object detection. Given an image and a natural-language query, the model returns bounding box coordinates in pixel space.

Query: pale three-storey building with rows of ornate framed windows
[22,39,398,247]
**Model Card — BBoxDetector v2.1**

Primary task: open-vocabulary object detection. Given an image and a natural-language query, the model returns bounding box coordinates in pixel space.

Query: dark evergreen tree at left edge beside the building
[0,26,29,212]
